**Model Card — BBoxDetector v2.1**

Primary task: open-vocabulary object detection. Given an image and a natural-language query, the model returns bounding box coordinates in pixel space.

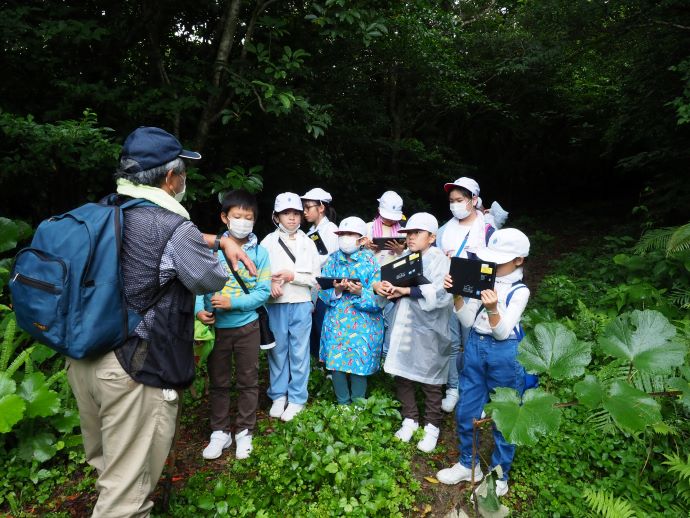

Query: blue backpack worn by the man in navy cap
[9,195,163,359]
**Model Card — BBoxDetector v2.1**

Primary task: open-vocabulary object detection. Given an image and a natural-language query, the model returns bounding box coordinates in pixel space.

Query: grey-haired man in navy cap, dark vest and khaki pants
[67,127,253,517]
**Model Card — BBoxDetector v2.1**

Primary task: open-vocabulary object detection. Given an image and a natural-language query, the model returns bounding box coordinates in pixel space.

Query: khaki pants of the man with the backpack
[67,352,179,517]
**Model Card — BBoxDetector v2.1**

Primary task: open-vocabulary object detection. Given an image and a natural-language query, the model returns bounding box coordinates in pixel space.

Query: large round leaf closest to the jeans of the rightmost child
[518,322,592,379]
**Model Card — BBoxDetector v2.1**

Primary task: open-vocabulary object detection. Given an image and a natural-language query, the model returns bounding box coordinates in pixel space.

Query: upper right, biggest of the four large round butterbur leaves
[599,309,686,372]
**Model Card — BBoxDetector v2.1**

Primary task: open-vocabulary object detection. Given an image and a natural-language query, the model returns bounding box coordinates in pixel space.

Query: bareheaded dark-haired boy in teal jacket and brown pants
[194,190,271,459]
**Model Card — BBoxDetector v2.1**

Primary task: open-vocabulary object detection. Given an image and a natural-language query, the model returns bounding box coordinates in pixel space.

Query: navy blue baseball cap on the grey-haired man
[120,126,201,173]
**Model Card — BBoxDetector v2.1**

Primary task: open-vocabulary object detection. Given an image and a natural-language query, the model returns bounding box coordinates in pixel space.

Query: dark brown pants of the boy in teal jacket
[208,320,260,433]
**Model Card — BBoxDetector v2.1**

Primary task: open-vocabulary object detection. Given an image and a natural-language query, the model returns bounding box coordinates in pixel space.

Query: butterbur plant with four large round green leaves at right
[486,310,690,446]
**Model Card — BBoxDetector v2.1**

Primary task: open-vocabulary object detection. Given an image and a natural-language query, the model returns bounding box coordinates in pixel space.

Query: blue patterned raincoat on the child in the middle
[319,249,385,376]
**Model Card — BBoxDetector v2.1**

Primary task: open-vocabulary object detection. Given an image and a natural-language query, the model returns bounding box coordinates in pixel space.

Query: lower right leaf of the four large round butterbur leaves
[603,380,661,433]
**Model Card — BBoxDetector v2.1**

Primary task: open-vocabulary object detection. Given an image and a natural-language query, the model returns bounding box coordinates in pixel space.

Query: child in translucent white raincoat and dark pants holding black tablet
[375,212,453,452]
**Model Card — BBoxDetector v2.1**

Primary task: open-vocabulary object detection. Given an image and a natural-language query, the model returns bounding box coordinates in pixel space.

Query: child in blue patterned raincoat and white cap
[319,217,383,405]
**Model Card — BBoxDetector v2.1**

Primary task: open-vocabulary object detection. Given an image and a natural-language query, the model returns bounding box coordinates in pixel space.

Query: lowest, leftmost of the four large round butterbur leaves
[486,387,561,446]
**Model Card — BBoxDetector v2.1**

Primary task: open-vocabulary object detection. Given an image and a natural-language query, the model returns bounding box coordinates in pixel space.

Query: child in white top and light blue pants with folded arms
[261,192,321,421]
